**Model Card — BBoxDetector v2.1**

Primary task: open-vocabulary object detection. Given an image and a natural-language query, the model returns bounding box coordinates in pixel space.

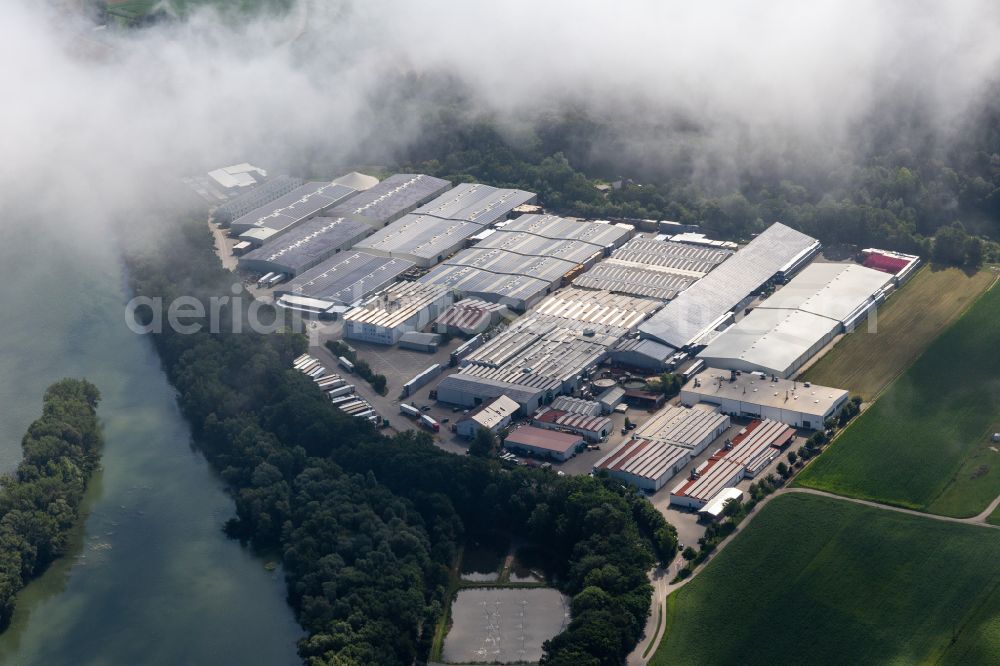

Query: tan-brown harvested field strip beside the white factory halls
[804,266,995,400]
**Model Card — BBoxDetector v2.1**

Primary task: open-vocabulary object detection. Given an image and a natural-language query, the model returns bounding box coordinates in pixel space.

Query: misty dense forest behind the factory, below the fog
[357,76,1000,265]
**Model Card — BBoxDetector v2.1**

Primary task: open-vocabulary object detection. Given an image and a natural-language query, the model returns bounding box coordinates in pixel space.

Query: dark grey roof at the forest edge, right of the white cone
[331,173,451,228]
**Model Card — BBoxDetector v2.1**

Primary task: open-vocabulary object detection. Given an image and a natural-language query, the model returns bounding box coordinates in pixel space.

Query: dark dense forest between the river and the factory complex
[121,223,676,666]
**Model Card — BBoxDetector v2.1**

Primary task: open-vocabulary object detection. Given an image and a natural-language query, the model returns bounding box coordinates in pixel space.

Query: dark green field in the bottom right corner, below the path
[650,494,1000,666]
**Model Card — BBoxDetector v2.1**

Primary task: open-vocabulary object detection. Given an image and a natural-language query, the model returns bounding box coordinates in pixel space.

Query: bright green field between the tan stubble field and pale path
[796,278,1000,517]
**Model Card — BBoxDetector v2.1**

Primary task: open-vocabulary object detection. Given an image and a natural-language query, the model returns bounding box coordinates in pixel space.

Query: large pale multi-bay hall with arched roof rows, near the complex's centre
[422,215,632,311]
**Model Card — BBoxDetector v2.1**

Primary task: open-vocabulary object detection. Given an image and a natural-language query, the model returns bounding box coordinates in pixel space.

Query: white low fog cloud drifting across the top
[0,0,1000,224]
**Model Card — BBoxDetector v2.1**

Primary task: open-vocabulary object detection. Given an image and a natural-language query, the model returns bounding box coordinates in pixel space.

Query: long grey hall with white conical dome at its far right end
[230,183,356,245]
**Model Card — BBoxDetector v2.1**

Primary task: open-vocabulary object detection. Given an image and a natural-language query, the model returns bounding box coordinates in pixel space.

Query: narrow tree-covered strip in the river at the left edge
[0,379,102,628]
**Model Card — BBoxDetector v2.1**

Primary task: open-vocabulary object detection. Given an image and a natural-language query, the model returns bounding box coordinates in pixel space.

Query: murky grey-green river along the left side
[0,220,302,666]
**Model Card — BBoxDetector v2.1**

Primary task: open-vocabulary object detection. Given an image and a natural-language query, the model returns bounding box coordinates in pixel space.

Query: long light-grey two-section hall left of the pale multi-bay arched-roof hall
[357,183,535,268]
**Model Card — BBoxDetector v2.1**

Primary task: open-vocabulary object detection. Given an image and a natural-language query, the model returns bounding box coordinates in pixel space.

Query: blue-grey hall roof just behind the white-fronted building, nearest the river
[275,252,413,305]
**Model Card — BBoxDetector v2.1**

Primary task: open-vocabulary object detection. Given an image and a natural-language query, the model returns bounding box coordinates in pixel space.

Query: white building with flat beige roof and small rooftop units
[681,368,849,430]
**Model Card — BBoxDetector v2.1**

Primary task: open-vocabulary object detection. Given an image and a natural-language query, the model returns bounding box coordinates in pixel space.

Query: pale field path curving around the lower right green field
[627,487,1000,666]
